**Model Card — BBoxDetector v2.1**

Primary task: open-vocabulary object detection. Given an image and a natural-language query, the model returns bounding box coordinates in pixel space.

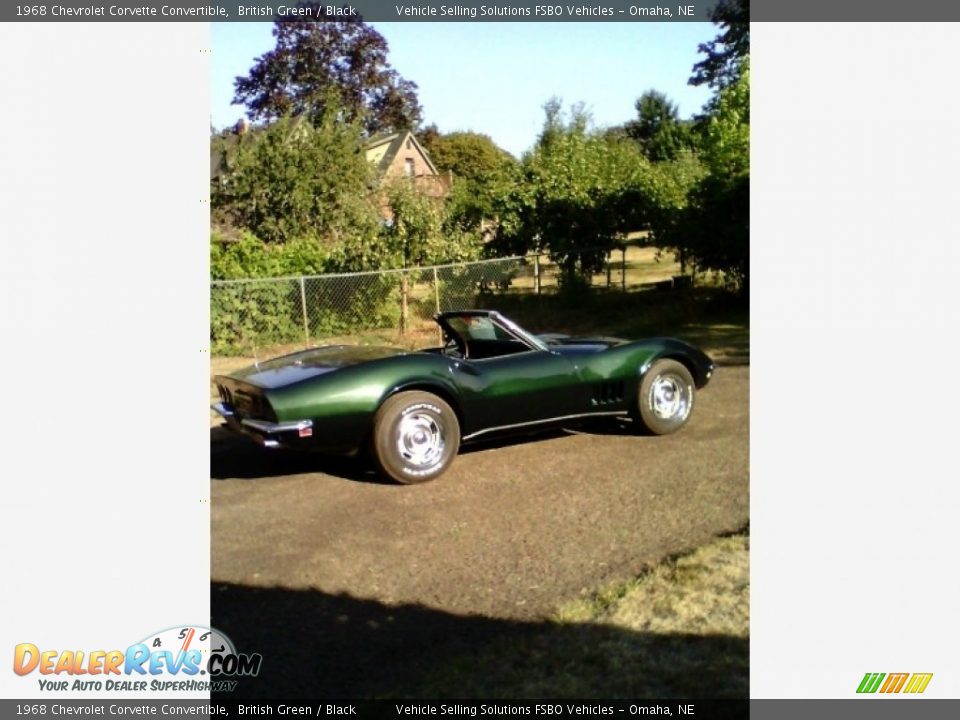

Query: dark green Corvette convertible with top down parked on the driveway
[213,310,714,483]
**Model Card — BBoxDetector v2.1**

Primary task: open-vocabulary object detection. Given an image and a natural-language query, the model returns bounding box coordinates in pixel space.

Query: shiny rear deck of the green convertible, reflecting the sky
[228,345,407,388]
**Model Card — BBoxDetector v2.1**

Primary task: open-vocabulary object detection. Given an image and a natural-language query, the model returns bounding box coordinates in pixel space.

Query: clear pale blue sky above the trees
[210,22,717,157]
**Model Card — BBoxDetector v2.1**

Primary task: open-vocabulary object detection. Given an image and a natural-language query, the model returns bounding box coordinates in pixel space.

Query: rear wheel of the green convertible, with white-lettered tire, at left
[372,391,460,485]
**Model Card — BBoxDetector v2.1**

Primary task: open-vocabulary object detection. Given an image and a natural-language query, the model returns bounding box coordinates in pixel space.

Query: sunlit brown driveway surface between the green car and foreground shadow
[211,367,749,620]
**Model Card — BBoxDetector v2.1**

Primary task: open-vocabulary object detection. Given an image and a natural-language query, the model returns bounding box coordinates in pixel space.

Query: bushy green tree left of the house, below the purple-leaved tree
[211,118,377,247]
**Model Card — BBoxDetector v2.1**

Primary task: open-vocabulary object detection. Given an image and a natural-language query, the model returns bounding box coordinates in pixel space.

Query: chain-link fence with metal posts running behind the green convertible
[210,248,675,356]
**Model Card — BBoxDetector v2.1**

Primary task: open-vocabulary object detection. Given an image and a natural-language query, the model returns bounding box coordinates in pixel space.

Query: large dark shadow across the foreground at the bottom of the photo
[211,581,749,700]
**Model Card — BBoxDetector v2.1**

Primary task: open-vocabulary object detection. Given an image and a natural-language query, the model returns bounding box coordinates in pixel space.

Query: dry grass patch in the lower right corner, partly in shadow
[396,530,750,699]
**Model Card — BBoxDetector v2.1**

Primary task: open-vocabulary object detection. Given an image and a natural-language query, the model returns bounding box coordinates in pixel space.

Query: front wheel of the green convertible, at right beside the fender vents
[637,360,696,435]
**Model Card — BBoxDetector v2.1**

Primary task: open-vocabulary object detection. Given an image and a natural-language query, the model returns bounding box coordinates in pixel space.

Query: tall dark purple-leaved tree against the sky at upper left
[233,11,422,134]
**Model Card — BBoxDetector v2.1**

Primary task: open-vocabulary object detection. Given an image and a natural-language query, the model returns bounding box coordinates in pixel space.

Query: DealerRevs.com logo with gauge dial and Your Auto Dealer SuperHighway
[13,625,263,692]
